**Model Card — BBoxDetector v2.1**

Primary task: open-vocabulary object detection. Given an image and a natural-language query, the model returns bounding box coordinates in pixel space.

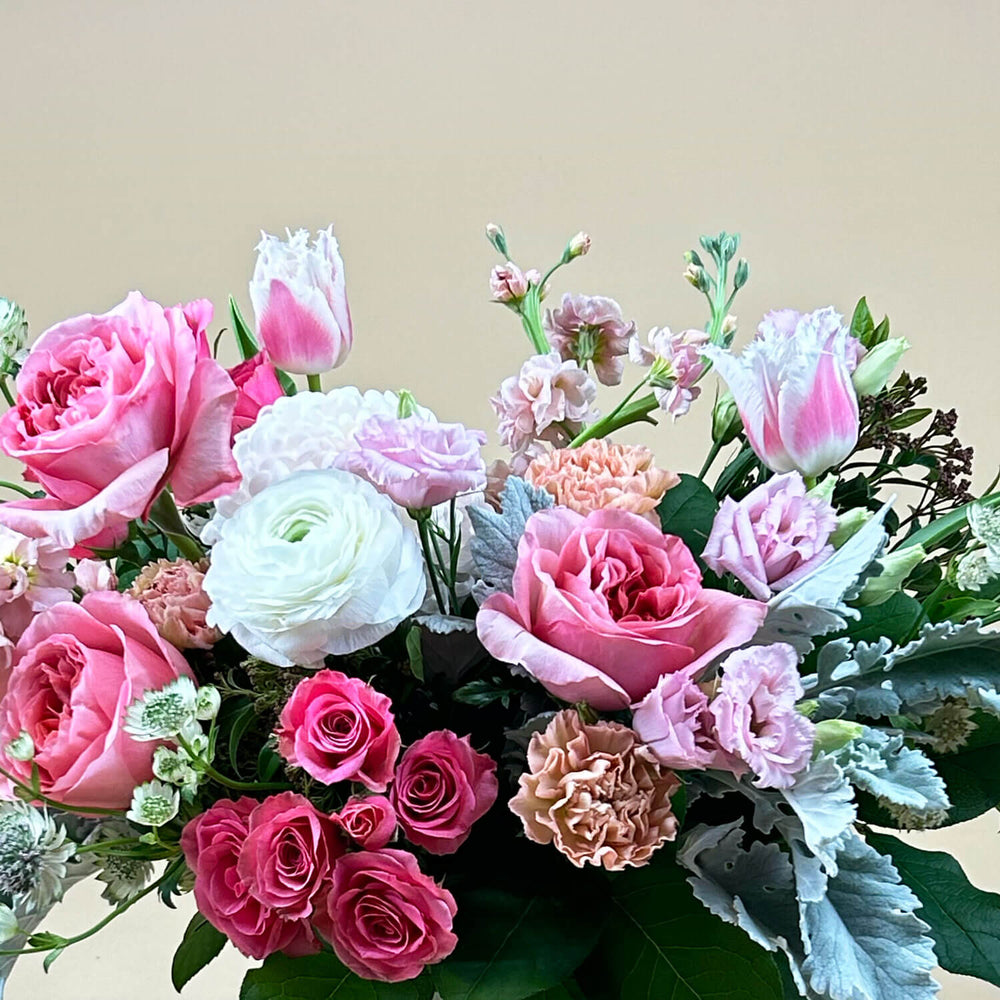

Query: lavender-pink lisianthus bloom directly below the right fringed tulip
[702,472,837,601]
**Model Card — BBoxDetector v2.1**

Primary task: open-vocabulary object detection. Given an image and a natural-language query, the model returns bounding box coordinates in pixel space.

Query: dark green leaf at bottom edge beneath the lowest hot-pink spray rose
[240,952,432,1000]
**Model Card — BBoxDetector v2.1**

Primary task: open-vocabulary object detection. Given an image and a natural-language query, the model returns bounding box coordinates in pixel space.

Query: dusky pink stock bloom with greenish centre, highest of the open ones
[545,294,635,385]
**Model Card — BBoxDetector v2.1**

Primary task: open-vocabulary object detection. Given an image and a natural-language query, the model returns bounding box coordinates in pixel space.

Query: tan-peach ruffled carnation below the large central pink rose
[510,709,680,871]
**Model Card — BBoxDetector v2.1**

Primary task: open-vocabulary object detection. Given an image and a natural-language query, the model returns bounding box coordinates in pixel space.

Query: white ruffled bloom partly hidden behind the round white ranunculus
[201,385,434,545]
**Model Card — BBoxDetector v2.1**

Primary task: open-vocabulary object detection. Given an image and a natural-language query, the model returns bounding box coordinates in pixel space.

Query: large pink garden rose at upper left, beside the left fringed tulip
[0,292,239,547]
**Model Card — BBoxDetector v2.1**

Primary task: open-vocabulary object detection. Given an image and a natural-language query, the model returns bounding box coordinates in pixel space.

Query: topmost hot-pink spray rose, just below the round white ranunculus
[278,670,400,792]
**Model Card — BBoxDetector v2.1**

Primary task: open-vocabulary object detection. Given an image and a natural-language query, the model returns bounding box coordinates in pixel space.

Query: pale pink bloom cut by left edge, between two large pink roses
[0,524,74,641]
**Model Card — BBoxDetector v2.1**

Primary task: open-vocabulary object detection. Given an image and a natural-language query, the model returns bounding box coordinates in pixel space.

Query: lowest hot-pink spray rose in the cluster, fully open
[314,850,458,983]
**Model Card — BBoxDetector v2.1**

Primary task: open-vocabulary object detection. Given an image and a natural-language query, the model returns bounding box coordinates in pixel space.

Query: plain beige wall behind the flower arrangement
[0,0,1000,1000]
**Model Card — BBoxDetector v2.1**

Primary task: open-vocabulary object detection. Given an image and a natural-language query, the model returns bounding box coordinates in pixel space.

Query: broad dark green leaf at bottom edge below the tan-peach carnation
[578,849,784,1000]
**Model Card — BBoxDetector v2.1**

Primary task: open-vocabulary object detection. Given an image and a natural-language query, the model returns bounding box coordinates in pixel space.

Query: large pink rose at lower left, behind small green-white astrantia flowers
[0,591,192,809]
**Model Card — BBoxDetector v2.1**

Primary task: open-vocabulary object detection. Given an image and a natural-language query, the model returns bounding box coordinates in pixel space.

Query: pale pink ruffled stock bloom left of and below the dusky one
[490,351,597,453]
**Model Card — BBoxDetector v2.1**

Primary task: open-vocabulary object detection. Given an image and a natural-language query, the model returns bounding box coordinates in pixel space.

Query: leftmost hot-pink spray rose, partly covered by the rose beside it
[181,797,320,959]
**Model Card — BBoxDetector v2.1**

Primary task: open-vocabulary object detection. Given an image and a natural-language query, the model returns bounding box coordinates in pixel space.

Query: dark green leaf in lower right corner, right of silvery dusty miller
[867,833,1000,986]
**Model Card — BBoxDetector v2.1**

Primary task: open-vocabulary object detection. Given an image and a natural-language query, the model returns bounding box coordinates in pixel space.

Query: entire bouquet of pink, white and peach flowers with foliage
[0,226,1000,1000]
